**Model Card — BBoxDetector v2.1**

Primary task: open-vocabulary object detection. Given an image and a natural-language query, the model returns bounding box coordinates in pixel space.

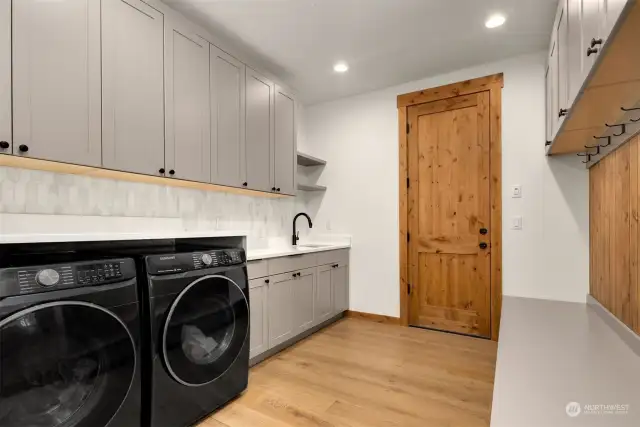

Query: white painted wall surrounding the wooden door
[299,52,589,316]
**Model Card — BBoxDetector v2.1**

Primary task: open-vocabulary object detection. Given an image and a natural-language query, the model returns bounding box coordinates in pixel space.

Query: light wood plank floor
[199,319,497,427]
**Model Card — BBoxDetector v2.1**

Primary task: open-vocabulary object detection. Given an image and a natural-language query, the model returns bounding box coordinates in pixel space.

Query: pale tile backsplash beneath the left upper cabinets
[0,167,306,247]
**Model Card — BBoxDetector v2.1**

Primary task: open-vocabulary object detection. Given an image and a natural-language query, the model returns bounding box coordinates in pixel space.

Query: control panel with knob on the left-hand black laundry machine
[0,258,136,297]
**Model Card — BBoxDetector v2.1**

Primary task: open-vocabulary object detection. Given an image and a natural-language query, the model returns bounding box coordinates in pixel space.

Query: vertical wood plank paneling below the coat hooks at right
[589,136,640,334]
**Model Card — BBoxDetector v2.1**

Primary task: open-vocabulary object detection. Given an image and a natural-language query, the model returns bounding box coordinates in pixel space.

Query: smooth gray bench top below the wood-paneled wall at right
[491,297,640,427]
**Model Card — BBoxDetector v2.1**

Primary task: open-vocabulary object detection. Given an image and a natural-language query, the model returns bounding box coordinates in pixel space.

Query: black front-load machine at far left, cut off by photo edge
[0,254,141,427]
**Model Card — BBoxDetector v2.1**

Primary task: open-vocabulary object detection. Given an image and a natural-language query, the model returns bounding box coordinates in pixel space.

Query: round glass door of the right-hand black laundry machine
[163,276,249,386]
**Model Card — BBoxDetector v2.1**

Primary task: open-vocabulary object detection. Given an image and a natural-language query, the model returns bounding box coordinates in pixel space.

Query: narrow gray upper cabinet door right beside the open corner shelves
[274,87,296,195]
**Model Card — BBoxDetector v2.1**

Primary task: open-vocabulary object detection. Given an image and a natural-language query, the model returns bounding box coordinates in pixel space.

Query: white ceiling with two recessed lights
[164,0,557,104]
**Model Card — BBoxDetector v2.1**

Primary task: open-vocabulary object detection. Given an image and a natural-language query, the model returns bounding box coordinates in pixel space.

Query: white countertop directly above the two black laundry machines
[0,230,247,244]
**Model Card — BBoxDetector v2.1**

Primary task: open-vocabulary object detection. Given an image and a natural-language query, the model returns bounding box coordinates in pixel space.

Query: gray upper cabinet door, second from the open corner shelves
[246,67,274,191]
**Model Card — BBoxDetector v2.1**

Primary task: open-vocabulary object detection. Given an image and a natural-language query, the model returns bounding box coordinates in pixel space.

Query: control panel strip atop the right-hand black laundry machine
[146,249,247,275]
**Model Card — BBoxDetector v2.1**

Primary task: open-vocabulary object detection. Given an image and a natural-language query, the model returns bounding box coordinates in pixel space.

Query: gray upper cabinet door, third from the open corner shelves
[210,45,245,187]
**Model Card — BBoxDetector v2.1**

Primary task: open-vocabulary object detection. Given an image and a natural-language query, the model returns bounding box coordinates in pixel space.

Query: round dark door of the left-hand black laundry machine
[0,301,136,427]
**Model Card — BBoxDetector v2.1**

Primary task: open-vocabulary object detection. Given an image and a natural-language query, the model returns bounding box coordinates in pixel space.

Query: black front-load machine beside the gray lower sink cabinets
[143,249,249,427]
